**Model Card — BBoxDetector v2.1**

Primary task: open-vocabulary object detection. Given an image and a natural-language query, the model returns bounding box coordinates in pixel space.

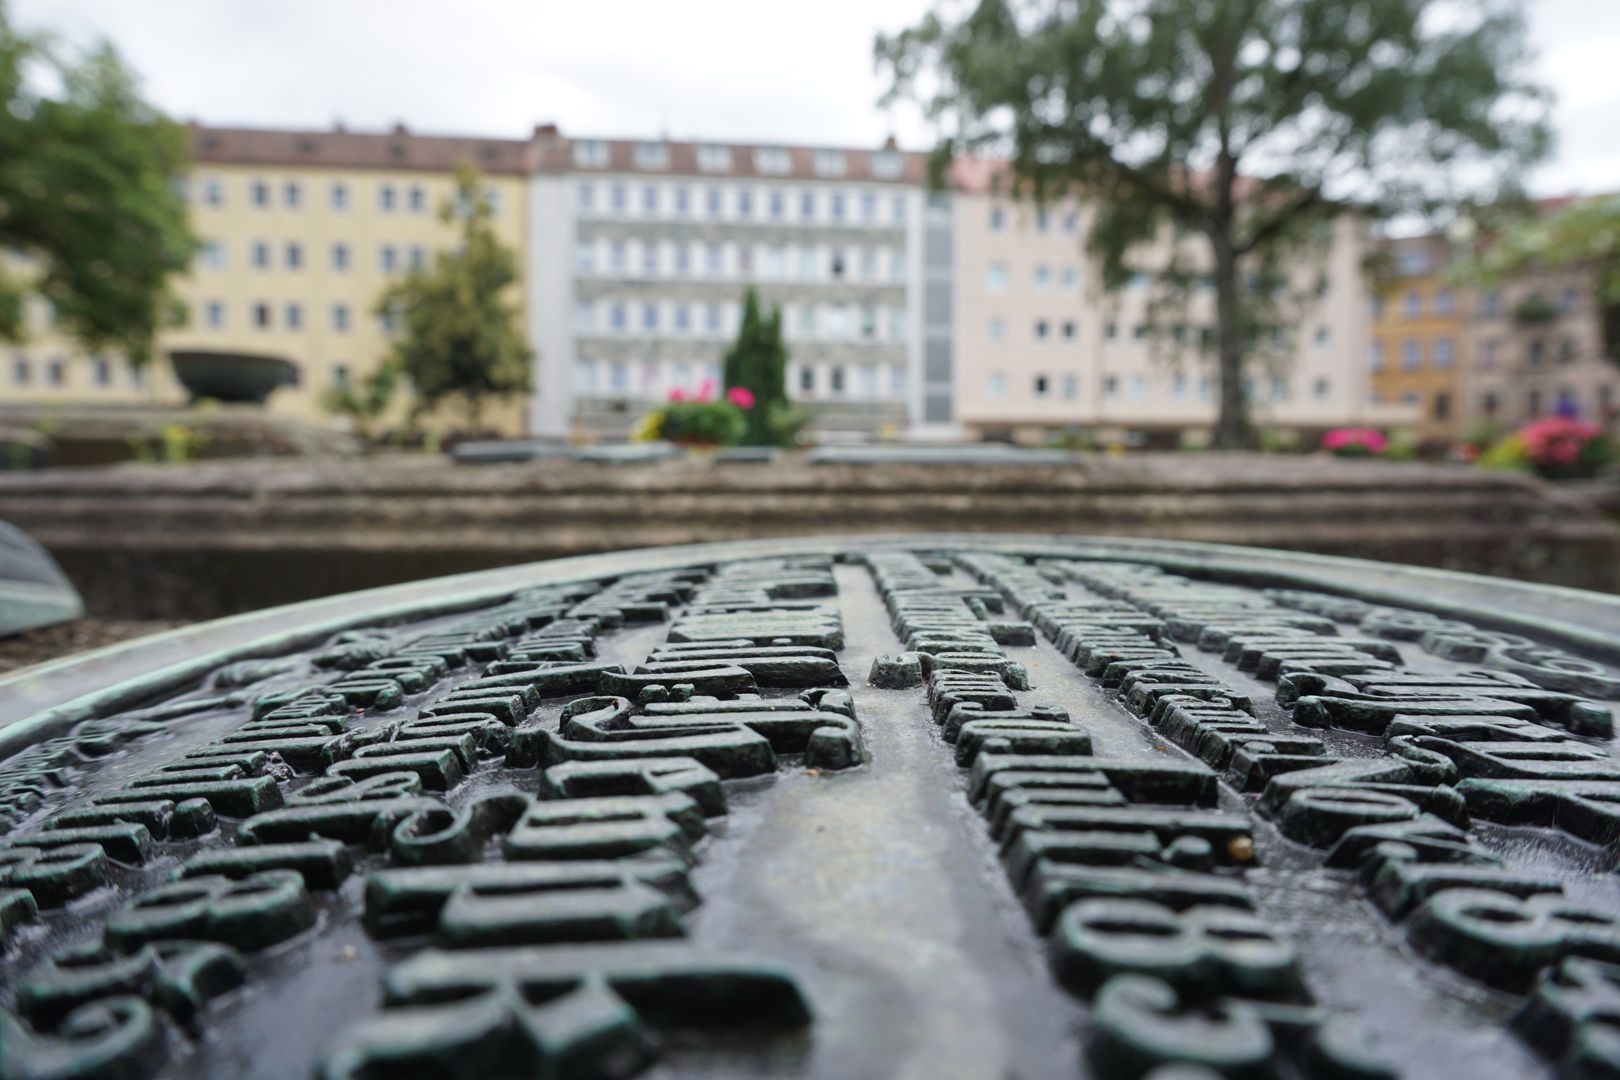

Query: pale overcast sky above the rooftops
[11,0,1620,194]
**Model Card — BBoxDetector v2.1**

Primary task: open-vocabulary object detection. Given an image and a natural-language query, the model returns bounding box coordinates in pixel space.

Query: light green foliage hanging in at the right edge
[1458,196,1620,361]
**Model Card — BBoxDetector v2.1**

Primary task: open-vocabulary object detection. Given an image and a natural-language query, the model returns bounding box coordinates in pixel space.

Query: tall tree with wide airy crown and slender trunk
[875,0,1547,447]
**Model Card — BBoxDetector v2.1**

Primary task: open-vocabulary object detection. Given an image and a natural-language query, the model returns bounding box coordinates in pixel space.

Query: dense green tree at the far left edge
[0,0,198,364]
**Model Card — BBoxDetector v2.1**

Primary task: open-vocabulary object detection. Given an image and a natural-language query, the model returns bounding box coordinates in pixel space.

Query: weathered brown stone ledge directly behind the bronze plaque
[0,453,1620,619]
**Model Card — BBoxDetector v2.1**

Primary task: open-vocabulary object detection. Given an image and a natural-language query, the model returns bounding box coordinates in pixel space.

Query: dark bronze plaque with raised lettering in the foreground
[0,536,1620,1080]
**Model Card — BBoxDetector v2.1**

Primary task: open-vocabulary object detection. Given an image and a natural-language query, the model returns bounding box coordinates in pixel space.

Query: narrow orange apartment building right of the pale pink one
[1367,236,1473,444]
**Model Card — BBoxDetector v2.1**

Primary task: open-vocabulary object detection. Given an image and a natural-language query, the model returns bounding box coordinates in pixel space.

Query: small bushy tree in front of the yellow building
[377,162,533,427]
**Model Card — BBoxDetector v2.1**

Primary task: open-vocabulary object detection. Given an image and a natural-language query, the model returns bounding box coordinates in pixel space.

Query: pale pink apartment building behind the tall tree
[951,162,1411,444]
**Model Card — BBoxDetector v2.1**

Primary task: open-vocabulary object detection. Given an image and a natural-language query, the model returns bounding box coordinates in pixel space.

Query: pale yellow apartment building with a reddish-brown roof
[0,125,530,432]
